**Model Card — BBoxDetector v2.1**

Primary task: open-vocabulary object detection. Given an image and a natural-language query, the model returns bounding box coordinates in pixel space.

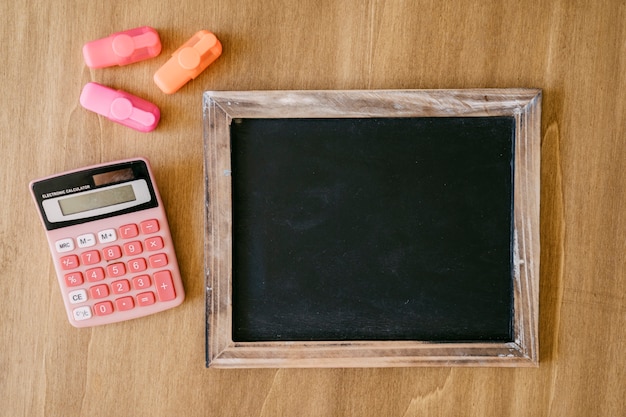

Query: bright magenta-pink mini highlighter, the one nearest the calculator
[80,83,161,132]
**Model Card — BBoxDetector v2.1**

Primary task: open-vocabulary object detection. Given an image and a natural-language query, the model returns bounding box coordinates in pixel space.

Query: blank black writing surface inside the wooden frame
[230,116,515,342]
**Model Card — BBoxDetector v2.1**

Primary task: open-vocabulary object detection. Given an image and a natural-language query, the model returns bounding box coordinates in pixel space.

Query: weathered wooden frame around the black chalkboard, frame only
[203,89,541,368]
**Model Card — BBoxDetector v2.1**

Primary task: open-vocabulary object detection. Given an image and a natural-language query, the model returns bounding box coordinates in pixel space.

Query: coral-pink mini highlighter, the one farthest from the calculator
[83,26,161,68]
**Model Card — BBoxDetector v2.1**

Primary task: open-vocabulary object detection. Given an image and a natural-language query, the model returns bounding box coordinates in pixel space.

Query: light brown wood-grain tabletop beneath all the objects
[0,0,626,417]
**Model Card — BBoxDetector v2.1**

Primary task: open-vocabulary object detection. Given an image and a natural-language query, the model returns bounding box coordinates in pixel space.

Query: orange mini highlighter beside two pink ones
[154,30,222,94]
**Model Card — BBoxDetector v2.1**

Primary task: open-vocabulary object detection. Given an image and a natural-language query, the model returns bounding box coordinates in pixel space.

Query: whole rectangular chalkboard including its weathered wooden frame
[205,90,540,366]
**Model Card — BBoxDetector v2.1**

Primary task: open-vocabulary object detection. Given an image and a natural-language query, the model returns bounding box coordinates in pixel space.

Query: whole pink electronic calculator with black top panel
[30,158,185,327]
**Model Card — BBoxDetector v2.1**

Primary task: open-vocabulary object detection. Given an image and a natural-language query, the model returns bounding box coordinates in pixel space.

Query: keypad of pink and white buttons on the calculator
[55,219,176,321]
